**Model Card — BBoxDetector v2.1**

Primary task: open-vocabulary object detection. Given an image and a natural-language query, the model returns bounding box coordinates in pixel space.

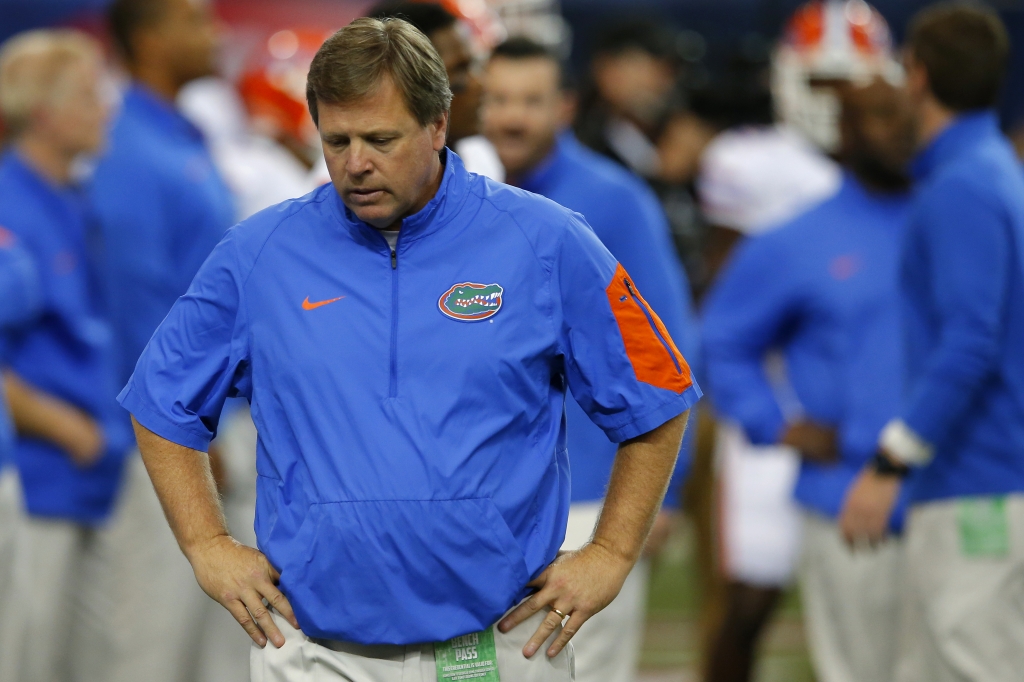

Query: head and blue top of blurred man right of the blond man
[90,0,236,393]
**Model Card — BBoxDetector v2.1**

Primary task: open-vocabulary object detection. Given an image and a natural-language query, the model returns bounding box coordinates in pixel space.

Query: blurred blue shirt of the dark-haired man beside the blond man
[90,85,237,385]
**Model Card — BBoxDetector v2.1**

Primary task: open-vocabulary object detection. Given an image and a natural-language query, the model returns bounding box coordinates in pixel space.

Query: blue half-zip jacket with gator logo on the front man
[120,152,700,644]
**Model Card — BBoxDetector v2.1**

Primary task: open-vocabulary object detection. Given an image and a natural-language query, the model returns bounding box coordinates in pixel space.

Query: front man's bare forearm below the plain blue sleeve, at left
[132,417,228,560]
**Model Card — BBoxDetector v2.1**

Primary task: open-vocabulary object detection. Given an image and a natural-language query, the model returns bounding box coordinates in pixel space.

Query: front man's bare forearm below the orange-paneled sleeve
[592,412,689,562]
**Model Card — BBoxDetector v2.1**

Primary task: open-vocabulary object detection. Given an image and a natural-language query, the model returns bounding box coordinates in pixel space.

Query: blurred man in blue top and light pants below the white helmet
[703,79,910,682]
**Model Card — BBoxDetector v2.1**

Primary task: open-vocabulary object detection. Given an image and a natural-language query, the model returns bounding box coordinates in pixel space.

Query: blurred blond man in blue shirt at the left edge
[0,26,131,682]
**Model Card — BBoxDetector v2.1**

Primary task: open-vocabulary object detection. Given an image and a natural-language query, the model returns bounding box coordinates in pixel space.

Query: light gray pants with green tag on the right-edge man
[895,495,1024,682]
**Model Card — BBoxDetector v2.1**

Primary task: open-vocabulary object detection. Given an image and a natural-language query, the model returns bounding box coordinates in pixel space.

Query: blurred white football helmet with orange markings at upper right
[771,0,902,153]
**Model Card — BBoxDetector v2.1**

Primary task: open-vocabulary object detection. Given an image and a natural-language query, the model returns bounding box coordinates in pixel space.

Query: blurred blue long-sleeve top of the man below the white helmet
[702,175,909,522]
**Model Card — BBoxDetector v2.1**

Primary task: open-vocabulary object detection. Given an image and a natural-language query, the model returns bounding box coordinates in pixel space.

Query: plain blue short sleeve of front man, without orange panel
[118,228,251,451]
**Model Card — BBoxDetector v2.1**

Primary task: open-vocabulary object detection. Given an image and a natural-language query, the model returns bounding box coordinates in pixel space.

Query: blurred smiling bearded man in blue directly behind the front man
[481,38,697,682]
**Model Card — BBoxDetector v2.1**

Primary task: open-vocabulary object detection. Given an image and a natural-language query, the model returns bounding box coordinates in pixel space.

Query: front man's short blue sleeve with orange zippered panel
[552,214,700,442]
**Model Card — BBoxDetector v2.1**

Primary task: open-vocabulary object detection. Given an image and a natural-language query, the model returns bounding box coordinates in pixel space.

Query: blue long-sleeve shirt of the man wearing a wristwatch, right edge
[900,112,1024,502]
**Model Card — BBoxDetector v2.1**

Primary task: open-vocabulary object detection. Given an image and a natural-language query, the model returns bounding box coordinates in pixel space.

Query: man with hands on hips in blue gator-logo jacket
[120,18,700,682]
